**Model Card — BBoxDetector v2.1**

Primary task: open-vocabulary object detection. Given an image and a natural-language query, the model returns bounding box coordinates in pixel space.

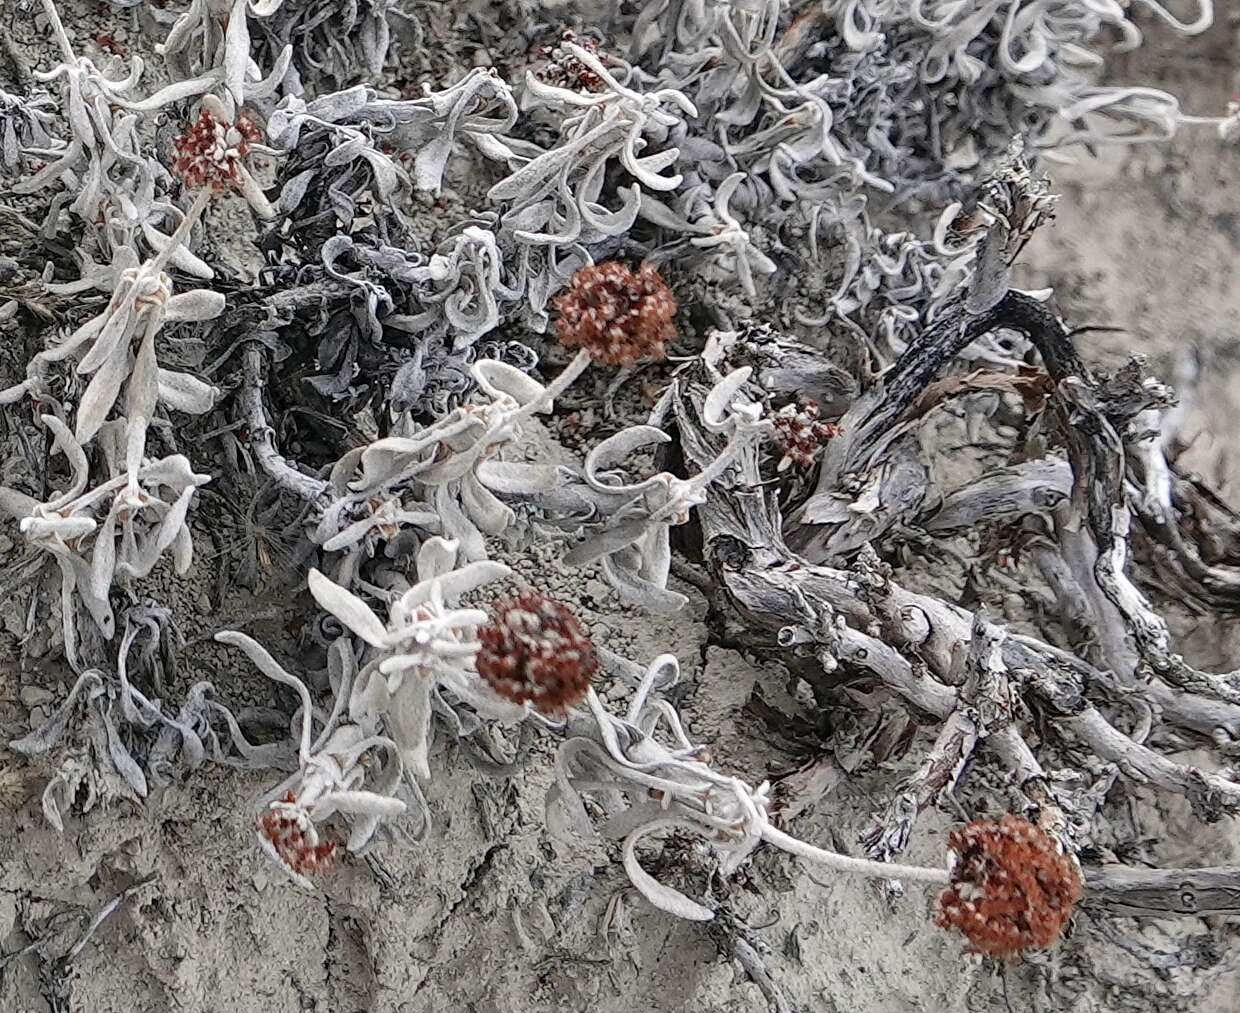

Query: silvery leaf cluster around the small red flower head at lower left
[216,627,407,889]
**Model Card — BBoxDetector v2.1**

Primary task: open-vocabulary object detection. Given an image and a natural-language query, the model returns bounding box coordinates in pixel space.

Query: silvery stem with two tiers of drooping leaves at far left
[0,237,224,670]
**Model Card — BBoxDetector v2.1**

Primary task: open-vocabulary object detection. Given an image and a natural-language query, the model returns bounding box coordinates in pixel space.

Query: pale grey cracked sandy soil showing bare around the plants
[0,1,1240,1013]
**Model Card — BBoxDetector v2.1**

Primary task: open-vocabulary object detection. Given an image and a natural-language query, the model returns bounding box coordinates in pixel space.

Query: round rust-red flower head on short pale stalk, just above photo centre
[556,260,676,366]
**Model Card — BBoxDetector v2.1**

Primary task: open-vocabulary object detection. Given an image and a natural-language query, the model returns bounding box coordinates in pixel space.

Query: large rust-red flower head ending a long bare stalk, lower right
[935,813,1083,957]
